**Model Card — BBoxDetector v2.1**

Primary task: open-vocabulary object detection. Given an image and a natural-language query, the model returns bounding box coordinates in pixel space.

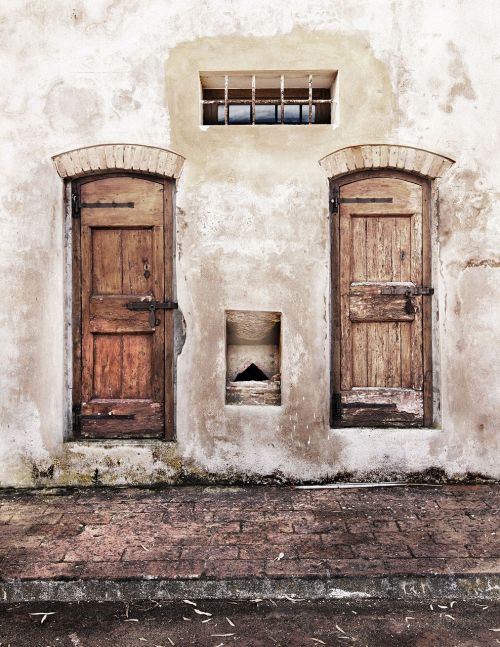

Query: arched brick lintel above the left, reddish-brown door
[52,144,184,179]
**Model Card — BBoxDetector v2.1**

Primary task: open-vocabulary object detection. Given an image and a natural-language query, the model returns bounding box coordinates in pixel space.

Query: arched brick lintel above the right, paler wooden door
[319,144,455,180]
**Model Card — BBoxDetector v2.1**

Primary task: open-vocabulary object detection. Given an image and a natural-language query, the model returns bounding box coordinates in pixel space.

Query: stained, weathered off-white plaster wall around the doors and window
[0,0,500,486]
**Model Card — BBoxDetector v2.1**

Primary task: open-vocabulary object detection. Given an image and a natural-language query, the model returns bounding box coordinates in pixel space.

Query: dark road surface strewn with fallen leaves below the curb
[0,600,500,647]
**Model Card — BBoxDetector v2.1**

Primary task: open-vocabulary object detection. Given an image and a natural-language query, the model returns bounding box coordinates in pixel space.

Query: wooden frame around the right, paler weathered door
[330,168,433,429]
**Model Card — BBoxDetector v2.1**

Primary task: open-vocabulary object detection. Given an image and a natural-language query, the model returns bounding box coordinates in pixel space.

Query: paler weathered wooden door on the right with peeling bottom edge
[332,173,432,427]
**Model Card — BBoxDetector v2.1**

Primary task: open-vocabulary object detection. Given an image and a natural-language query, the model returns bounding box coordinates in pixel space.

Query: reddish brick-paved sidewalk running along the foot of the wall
[0,485,500,599]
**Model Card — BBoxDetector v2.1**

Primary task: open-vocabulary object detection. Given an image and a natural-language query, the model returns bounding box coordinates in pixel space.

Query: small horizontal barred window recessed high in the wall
[200,72,337,126]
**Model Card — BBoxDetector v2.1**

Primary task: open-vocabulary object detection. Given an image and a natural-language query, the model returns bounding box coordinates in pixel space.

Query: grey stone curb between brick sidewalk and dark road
[0,573,500,603]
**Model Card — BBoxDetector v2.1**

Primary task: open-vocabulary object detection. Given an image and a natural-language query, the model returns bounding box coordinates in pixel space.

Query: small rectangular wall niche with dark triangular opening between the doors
[226,310,281,405]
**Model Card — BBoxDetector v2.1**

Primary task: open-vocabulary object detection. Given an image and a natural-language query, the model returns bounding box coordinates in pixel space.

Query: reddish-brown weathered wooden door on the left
[73,176,175,438]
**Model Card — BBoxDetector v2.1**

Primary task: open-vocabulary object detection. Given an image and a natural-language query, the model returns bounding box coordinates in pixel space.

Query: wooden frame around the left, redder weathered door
[64,170,176,443]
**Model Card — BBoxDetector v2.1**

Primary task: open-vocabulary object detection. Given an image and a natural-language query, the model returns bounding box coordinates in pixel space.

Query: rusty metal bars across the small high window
[201,74,337,126]
